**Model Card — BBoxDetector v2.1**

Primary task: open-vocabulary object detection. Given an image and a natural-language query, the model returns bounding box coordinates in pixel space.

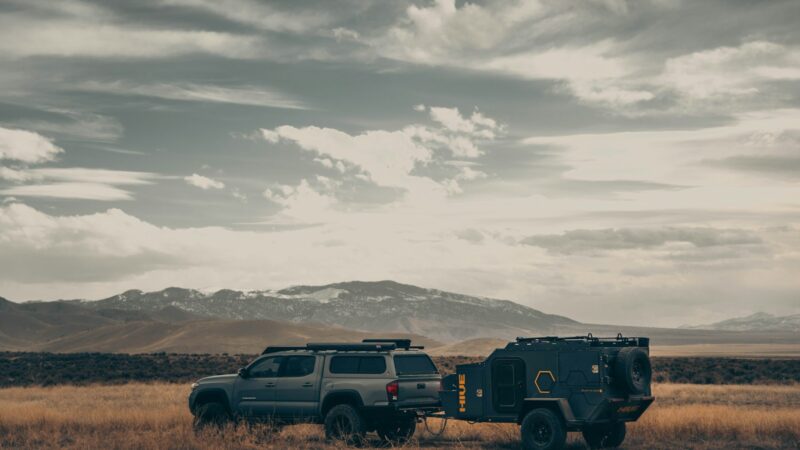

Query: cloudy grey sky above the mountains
[0,0,800,326]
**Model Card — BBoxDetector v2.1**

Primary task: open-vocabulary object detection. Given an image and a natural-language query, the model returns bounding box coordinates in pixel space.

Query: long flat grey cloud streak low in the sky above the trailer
[521,227,762,254]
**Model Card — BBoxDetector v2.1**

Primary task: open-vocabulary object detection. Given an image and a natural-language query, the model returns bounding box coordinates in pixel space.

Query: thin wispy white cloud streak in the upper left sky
[79,81,308,109]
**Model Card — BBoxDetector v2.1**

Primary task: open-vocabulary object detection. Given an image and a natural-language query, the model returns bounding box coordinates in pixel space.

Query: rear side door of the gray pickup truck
[275,355,322,419]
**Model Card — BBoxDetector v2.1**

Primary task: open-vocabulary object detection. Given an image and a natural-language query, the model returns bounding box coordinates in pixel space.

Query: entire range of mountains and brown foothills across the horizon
[0,281,797,354]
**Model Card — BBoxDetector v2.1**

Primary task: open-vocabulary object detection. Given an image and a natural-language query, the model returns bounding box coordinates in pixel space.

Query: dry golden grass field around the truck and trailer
[0,384,800,450]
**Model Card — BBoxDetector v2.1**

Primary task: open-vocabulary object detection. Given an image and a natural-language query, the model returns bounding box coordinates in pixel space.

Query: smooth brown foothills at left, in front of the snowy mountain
[0,298,441,353]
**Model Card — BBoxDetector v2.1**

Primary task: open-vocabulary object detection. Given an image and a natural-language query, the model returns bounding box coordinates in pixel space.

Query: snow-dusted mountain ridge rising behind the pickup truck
[75,281,578,342]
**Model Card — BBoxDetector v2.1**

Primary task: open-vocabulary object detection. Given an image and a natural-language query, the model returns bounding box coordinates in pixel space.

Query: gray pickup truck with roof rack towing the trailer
[189,339,441,442]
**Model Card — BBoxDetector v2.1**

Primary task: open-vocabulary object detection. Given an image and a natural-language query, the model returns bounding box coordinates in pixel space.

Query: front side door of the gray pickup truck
[234,356,285,417]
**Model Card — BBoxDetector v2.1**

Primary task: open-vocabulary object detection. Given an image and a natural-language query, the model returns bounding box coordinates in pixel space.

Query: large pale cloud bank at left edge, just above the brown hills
[0,203,191,283]
